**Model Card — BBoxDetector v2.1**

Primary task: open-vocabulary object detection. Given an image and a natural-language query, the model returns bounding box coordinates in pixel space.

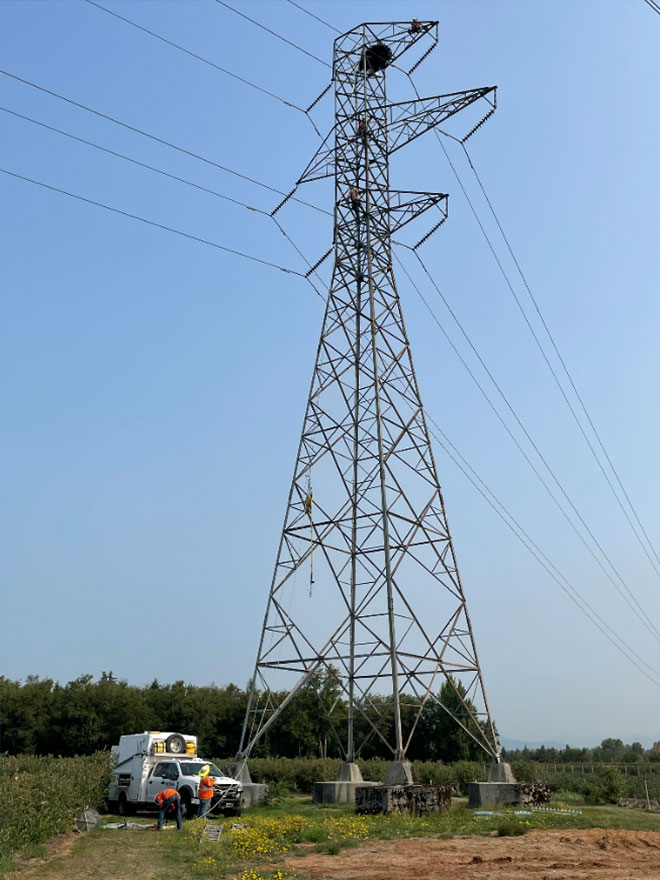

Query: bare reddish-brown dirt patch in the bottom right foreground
[286,828,660,880]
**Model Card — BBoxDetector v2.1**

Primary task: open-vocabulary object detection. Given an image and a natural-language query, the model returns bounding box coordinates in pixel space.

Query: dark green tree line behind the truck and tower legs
[0,672,485,762]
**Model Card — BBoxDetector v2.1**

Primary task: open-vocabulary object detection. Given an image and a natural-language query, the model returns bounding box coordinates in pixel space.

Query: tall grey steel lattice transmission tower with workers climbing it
[239,20,499,762]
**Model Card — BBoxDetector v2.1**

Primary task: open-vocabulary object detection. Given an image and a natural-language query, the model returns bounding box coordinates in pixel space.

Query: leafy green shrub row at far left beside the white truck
[0,752,110,857]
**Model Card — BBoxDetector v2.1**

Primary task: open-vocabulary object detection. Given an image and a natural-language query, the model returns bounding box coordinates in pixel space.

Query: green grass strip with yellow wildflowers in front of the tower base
[7,794,660,880]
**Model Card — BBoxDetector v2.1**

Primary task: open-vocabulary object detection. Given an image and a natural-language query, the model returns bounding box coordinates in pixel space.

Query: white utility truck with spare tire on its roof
[108,731,243,817]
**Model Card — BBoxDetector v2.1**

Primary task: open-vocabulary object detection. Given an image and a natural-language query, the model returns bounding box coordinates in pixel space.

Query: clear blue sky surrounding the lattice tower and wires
[0,0,660,742]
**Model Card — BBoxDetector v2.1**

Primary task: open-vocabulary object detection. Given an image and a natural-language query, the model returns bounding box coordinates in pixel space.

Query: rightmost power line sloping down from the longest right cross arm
[462,144,660,577]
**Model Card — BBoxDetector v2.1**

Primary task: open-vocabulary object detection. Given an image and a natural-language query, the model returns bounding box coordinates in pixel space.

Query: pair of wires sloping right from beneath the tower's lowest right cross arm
[399,251,659,638]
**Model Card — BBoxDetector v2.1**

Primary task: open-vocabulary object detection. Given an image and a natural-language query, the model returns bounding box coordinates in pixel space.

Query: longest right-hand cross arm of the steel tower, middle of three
[387,86,497,154]
